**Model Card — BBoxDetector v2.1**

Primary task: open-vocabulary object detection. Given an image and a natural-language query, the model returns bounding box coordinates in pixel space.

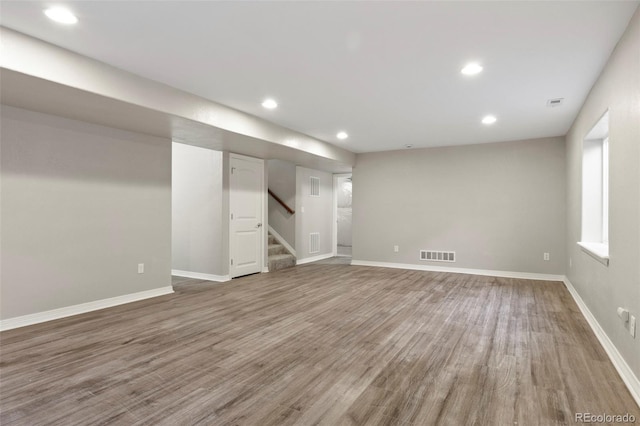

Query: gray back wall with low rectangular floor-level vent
[353,138,565,274]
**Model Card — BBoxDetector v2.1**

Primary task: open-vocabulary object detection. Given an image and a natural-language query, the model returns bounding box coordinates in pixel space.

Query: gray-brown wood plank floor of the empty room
[0,263,640,426]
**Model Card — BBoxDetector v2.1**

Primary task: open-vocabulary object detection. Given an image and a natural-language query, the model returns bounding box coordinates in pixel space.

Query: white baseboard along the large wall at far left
[0,286,173,331]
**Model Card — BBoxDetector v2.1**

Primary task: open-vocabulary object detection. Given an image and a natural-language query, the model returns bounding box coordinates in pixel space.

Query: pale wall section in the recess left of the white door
[171,143,225,275]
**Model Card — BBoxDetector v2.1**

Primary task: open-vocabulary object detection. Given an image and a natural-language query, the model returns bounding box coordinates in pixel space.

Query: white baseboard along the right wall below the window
[563,277,640,406]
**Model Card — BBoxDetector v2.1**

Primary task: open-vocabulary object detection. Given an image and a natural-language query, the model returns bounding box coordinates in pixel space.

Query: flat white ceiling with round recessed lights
[0,1,638,152]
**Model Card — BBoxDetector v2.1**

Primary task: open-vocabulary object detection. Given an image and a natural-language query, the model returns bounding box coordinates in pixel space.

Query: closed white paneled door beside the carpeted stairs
[229,154,264,278]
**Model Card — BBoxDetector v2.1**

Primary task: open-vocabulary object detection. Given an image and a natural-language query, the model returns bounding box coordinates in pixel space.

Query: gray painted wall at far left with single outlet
[0,106,171,319]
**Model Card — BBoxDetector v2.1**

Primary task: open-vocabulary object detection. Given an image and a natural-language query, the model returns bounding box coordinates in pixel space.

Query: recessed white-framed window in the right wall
[578,111,609,265]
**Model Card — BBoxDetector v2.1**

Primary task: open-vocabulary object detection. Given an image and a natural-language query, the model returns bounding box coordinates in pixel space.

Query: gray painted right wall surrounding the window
[565,10,640,377]
